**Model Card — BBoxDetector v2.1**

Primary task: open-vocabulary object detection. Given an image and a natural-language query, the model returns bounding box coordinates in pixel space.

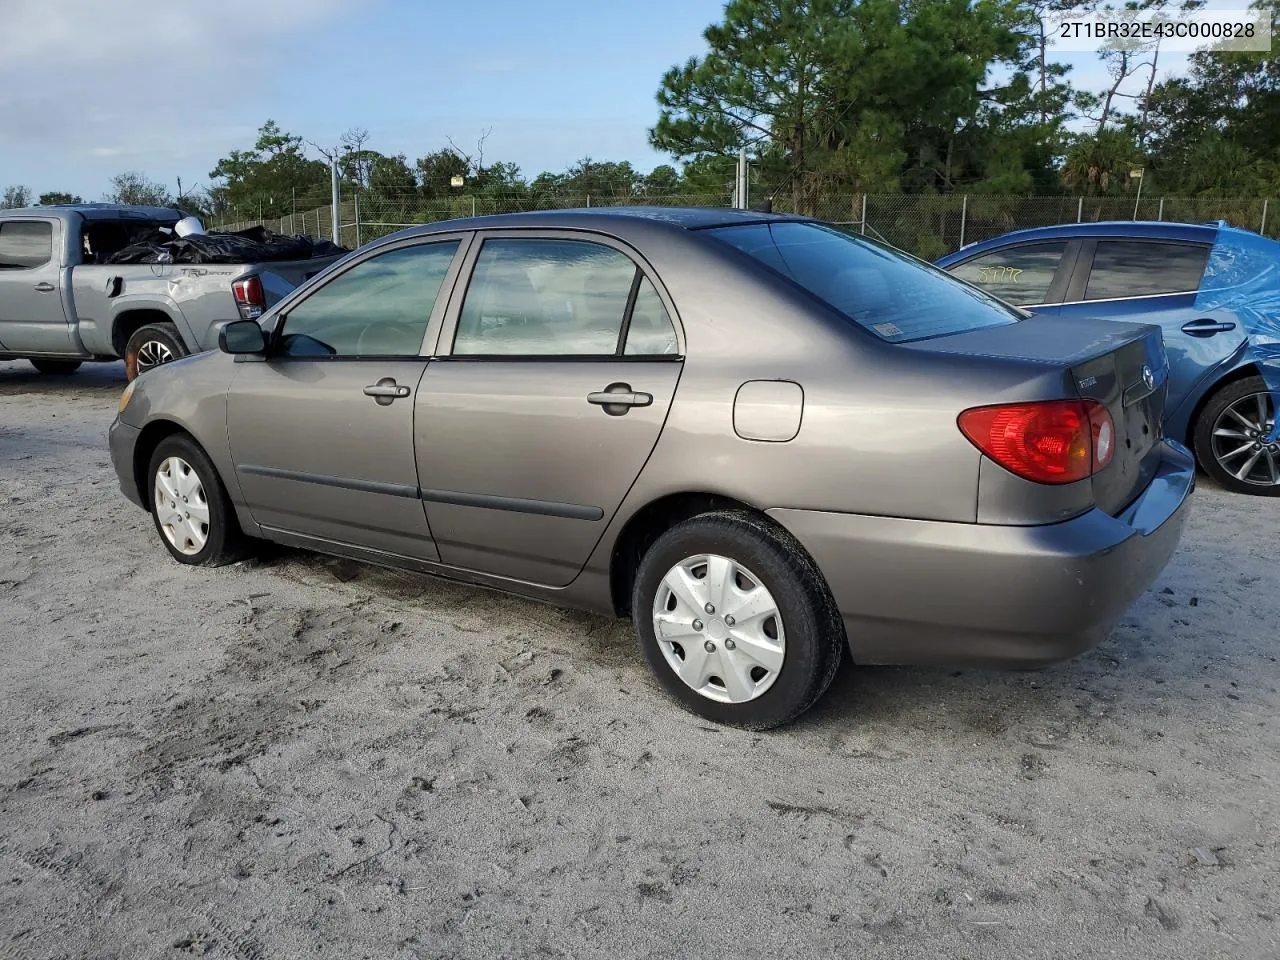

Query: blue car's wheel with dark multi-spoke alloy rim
[1194,376,1280,497]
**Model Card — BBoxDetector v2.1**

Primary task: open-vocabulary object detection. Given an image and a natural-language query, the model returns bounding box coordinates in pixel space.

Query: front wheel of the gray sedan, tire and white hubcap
[147,435,246,567]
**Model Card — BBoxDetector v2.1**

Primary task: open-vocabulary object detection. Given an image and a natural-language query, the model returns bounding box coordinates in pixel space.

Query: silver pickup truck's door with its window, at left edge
[0,218,71,353]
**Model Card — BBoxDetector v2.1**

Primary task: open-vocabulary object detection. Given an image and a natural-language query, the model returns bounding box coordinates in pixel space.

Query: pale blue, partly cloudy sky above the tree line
[0,0,1219,200]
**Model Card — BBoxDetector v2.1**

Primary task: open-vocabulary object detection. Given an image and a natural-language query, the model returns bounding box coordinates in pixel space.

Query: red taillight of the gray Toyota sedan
[959,401,1115,484]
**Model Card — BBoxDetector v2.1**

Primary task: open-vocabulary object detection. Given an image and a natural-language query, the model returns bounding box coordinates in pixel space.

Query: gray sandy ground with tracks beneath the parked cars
[0,364,1280,960]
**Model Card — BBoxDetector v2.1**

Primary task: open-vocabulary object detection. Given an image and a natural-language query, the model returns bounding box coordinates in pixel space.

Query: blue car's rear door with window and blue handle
[1059,237,1247,413]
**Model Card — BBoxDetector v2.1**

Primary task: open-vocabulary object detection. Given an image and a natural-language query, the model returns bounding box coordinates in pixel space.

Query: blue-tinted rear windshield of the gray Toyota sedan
[707,221,1024,343]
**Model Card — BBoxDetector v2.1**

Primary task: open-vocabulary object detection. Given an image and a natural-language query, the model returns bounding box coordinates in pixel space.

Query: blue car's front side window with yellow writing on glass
[947,239,1080,314]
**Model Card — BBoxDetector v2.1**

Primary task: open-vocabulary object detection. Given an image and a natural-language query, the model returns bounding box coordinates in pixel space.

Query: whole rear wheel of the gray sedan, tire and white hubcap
[631,511,845,730]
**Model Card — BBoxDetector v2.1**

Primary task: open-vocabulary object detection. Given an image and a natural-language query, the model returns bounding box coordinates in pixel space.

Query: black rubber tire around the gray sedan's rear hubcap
[631,511,845,730]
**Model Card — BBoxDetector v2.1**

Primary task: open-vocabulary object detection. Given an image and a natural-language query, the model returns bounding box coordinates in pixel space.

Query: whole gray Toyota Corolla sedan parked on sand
[110,209,1194,727]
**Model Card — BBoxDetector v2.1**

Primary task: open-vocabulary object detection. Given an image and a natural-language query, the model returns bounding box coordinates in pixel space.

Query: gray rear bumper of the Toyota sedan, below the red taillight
[769,440,1196,667]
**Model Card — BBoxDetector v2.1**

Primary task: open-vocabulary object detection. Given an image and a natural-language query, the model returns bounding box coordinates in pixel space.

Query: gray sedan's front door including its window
[227,237,471,561]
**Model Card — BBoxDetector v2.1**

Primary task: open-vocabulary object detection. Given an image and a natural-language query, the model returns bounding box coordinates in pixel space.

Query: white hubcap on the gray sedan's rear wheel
[653,554,786,703]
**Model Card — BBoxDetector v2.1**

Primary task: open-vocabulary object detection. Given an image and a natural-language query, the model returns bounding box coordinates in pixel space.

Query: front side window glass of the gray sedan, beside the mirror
[275,241,458,357]
